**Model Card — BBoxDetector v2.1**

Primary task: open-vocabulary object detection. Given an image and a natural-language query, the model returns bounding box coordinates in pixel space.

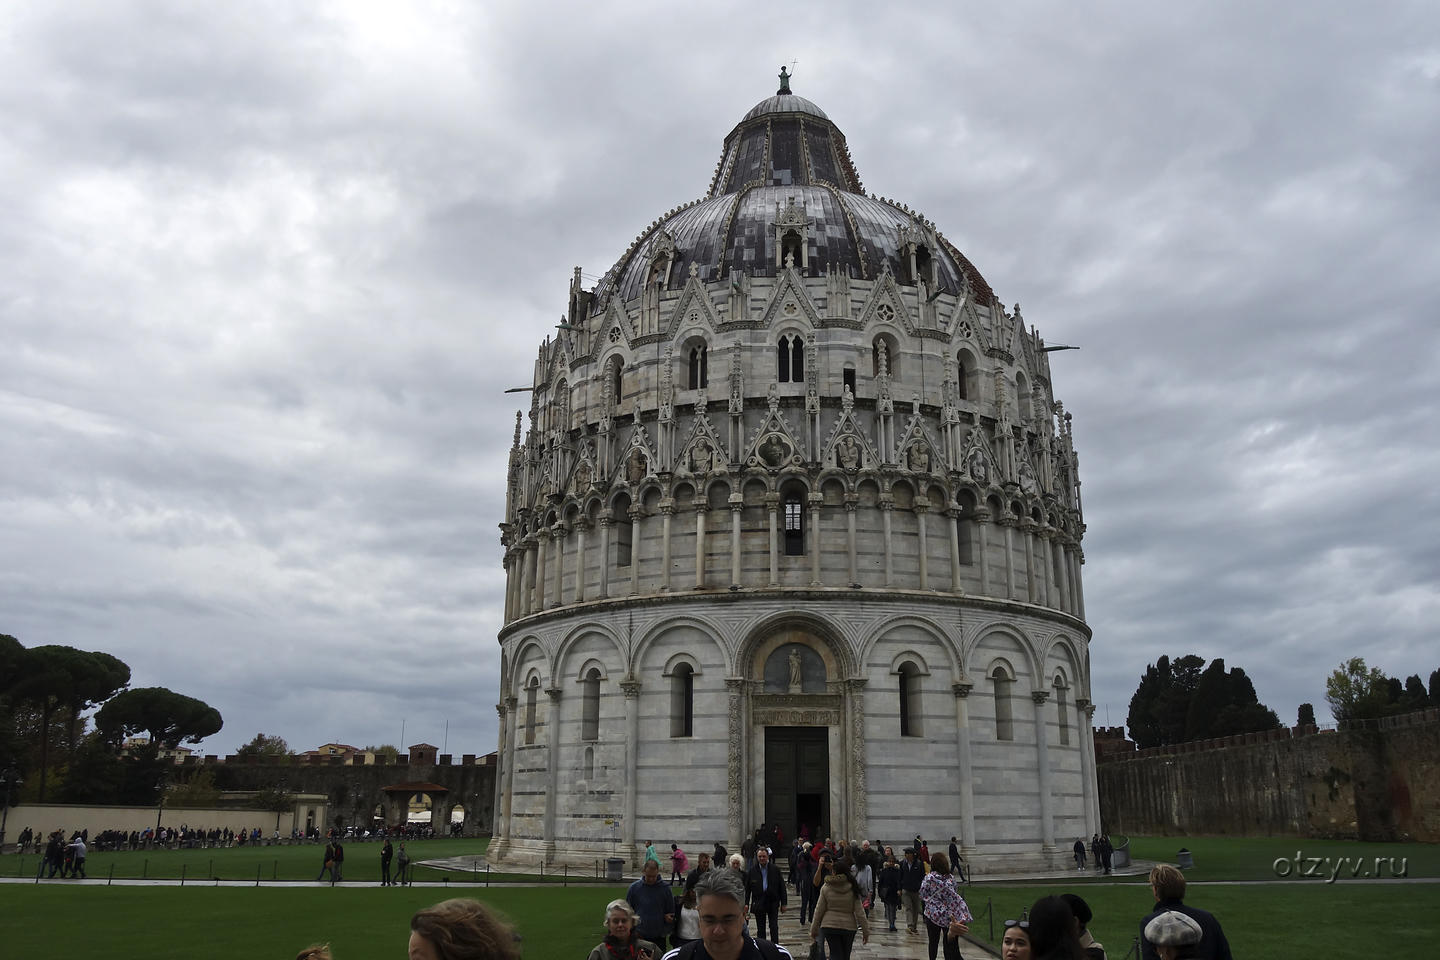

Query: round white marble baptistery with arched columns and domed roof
[490,75,1099,866]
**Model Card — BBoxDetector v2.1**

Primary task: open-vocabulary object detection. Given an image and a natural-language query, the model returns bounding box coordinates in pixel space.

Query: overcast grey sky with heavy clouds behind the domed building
[0,0,1440,754]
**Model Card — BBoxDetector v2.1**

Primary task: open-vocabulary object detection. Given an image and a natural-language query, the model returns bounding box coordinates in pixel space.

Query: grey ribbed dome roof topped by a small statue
[595,78,991,309]
